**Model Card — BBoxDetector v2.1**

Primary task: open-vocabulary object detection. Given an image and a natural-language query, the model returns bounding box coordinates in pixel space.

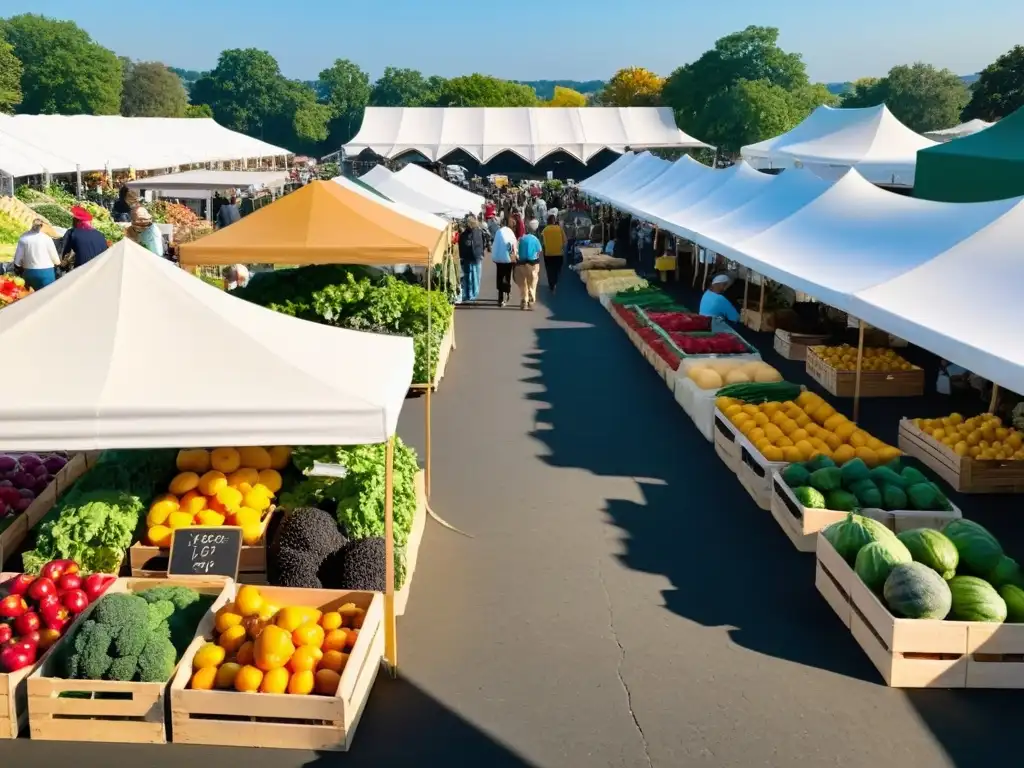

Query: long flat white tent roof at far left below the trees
[0,115,292,178]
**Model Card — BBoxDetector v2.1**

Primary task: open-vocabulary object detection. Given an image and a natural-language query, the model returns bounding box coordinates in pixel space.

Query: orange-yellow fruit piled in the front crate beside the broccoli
[188,585,366,696]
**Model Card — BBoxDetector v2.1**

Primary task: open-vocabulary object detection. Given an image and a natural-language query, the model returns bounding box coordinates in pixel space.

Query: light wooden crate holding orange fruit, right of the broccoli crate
[170,587,384,751]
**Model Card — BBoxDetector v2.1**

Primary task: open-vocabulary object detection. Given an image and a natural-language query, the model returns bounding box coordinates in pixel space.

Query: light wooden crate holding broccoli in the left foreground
[28,577,234,744]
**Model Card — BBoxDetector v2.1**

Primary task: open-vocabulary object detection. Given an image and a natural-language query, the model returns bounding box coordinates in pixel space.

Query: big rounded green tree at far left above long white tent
[0,13,123,115]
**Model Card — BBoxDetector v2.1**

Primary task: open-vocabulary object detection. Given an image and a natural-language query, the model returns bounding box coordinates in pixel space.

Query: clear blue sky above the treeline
[8,0,1024,82]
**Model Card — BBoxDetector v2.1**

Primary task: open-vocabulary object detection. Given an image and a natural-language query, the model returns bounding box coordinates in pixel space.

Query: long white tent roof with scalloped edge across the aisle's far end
[344,106,707,163]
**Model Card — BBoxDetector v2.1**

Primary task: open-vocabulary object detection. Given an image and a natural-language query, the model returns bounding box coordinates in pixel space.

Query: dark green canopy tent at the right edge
[913,108,1024,203]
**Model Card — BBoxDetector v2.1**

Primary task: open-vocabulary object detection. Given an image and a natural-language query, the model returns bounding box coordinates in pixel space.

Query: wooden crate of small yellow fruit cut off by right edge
[898,419,1024,494]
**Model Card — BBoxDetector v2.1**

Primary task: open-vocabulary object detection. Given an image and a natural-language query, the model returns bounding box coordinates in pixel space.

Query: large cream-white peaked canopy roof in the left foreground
[0,240,413,451]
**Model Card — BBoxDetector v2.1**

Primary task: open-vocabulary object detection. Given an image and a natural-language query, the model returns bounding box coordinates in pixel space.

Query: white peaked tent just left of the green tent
[740,104,936,186]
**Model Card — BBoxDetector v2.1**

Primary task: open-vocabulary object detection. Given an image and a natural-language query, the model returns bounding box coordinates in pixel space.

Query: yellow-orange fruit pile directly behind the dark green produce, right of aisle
[715,391,901,467]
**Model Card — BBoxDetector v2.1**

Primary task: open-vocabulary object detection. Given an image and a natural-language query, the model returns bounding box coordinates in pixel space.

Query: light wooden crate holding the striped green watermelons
[814,534,1024,688]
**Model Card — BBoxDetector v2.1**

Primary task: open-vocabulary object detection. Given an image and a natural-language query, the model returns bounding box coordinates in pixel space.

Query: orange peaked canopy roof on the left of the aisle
[180,179,447,265]
